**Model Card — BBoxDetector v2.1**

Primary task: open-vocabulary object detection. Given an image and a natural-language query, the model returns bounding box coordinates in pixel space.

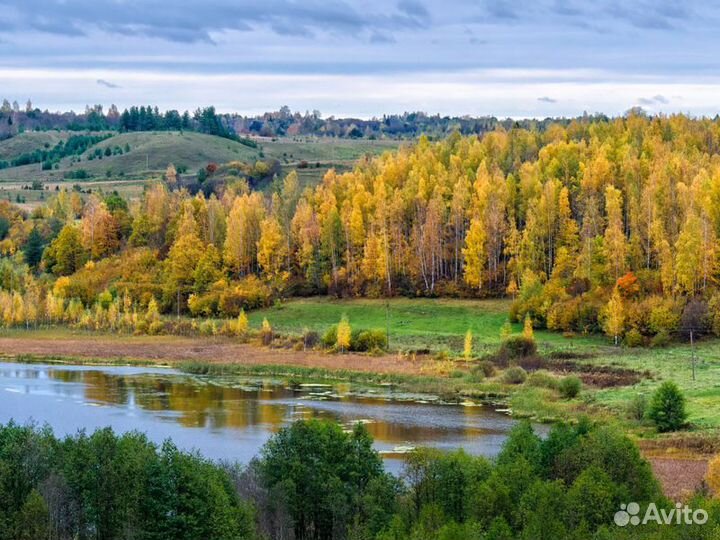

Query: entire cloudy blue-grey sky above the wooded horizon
[0,0,720,118]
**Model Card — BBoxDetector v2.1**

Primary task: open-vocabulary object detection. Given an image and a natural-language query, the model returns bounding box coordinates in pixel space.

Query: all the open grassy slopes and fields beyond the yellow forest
[0,131,400,197]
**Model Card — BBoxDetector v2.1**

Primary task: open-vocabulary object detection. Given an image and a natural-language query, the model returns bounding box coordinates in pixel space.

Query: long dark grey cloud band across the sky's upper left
[0,0,429,43]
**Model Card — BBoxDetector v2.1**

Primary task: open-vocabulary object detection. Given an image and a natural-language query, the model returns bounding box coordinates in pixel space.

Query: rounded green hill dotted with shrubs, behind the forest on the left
[0,131,258,182]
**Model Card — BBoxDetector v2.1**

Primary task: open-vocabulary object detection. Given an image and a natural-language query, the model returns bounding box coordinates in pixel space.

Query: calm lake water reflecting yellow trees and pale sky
[0,363,528,472]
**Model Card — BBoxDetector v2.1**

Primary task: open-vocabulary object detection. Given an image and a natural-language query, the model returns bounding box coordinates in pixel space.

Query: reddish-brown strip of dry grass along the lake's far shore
[0,336,434,375]
